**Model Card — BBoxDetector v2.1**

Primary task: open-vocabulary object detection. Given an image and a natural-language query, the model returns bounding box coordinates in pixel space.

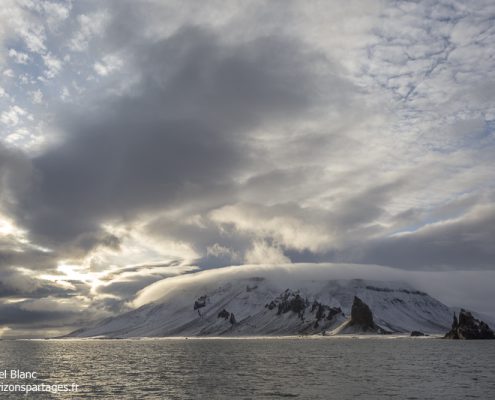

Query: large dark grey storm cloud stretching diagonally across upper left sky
[11,28,328,251]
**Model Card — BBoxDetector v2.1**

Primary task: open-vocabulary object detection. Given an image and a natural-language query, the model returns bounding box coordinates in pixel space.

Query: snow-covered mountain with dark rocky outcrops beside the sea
[69,266,453,338]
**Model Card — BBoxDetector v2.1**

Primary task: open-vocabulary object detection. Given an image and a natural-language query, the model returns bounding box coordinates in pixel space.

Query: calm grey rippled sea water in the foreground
[0,338,495,400]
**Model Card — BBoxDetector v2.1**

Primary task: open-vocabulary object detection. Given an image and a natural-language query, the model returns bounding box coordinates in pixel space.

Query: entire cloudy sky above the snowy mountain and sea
[0,0,495,337]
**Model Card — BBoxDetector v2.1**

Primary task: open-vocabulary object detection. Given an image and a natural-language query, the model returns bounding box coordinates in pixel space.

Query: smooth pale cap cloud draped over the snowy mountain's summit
[134,263,495,317]
